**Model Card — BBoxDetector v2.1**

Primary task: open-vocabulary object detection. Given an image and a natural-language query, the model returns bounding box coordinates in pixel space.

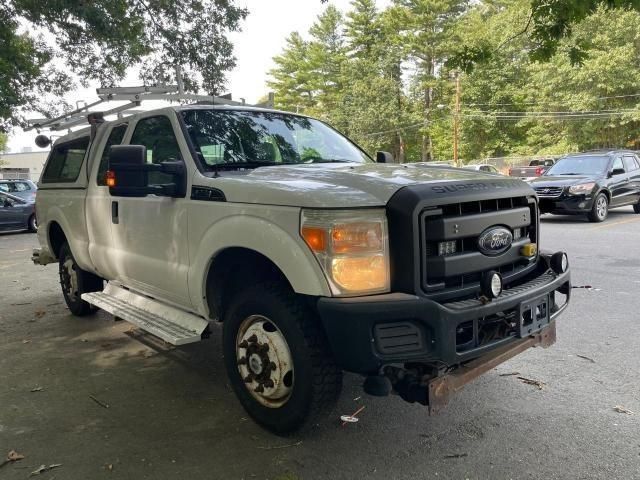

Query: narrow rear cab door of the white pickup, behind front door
[86,123,127,280]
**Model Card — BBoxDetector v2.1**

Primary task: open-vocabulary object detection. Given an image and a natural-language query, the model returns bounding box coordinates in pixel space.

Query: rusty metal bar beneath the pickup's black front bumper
[427,321,556,415]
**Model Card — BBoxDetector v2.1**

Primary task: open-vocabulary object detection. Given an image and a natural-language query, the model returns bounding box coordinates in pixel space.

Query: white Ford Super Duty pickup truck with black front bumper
[33,105,571,433]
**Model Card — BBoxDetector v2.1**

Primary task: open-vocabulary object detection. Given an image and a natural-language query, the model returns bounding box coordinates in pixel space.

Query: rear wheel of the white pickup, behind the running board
[58,242,104,317]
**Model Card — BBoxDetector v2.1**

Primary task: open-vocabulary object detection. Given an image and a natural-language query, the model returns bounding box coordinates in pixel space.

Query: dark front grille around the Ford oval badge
[419,197,538,298]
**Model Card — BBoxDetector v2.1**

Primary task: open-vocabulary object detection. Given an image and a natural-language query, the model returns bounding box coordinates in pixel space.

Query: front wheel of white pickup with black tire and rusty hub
[223,282,342,435]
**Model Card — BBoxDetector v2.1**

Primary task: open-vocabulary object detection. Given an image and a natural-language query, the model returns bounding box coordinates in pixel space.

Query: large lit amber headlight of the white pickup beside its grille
[300,209,389,295]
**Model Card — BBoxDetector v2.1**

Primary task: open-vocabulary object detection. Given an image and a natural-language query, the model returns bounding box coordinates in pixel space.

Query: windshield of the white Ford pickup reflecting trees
[182,109,371,171]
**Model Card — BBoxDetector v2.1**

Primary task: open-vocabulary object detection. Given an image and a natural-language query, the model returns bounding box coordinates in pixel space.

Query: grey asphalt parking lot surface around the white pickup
[0,208,640,480]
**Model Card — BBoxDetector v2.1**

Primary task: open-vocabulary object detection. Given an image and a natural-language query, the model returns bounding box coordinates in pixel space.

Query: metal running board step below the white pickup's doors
[82,282,209,345]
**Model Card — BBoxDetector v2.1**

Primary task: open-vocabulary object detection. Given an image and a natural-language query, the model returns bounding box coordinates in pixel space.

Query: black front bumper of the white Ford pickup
[317,255,571,374]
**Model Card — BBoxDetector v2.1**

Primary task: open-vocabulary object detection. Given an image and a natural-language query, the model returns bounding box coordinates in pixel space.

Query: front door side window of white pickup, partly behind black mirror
[129,115,182,185]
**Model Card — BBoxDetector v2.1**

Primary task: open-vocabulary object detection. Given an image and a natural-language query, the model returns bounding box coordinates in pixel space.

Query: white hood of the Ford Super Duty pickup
[204,163,523,208]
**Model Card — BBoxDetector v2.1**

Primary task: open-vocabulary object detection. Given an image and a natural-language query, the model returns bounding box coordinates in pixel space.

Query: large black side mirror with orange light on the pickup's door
[107,145,187,197]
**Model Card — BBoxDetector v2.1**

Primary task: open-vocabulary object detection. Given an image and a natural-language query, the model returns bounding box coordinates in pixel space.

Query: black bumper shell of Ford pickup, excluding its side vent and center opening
[317,258,571,374]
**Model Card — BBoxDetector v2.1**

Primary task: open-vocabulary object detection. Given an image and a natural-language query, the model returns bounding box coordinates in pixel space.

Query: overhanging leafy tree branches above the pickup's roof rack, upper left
[0,0,247,129]
